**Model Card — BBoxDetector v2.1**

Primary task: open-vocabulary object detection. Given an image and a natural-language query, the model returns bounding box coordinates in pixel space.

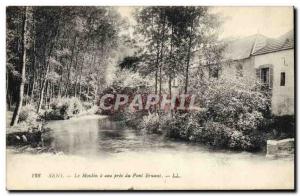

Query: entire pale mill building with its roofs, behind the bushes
[209,31,295,116]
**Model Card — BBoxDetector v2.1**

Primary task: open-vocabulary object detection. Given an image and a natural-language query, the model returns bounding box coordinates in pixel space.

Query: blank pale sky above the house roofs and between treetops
[117,6,294,38]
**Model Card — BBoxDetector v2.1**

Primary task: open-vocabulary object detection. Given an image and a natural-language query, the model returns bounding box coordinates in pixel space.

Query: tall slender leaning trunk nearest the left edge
[11,7,32,126]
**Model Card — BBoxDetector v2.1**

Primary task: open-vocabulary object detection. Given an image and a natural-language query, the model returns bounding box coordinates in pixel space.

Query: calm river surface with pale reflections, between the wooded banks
[47,118,268,159]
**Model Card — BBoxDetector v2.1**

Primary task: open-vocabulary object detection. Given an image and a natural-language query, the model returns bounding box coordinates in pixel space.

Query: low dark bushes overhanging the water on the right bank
[158,110,265,151]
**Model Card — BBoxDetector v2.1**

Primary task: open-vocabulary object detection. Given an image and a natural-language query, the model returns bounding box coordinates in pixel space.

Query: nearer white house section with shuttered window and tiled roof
[252,31,295,115]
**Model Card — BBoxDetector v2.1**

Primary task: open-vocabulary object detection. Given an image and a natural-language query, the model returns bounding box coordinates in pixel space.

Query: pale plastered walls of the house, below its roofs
[172,49,295,116]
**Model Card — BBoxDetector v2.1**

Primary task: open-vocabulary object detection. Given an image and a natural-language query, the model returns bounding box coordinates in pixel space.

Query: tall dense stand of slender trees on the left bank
[6,6,124,118]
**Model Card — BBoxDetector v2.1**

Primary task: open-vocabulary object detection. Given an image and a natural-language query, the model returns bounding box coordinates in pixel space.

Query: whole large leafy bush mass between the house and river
[149,79,269,151]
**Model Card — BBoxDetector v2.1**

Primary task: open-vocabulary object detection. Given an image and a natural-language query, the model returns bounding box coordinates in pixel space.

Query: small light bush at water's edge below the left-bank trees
[44,97,83,120]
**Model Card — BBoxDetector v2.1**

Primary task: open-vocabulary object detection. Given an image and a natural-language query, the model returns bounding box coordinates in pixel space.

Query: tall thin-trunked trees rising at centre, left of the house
[136,6,220,94]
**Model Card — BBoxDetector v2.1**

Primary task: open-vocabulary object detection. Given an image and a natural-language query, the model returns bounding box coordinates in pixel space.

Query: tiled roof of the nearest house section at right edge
[253,31,294,55]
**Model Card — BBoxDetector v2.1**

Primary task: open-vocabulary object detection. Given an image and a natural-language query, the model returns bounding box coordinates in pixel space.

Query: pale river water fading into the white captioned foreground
[7,117,294,189]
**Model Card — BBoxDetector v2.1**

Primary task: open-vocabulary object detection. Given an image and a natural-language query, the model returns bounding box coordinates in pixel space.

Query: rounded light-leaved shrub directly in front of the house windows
[201,79,270,131]
